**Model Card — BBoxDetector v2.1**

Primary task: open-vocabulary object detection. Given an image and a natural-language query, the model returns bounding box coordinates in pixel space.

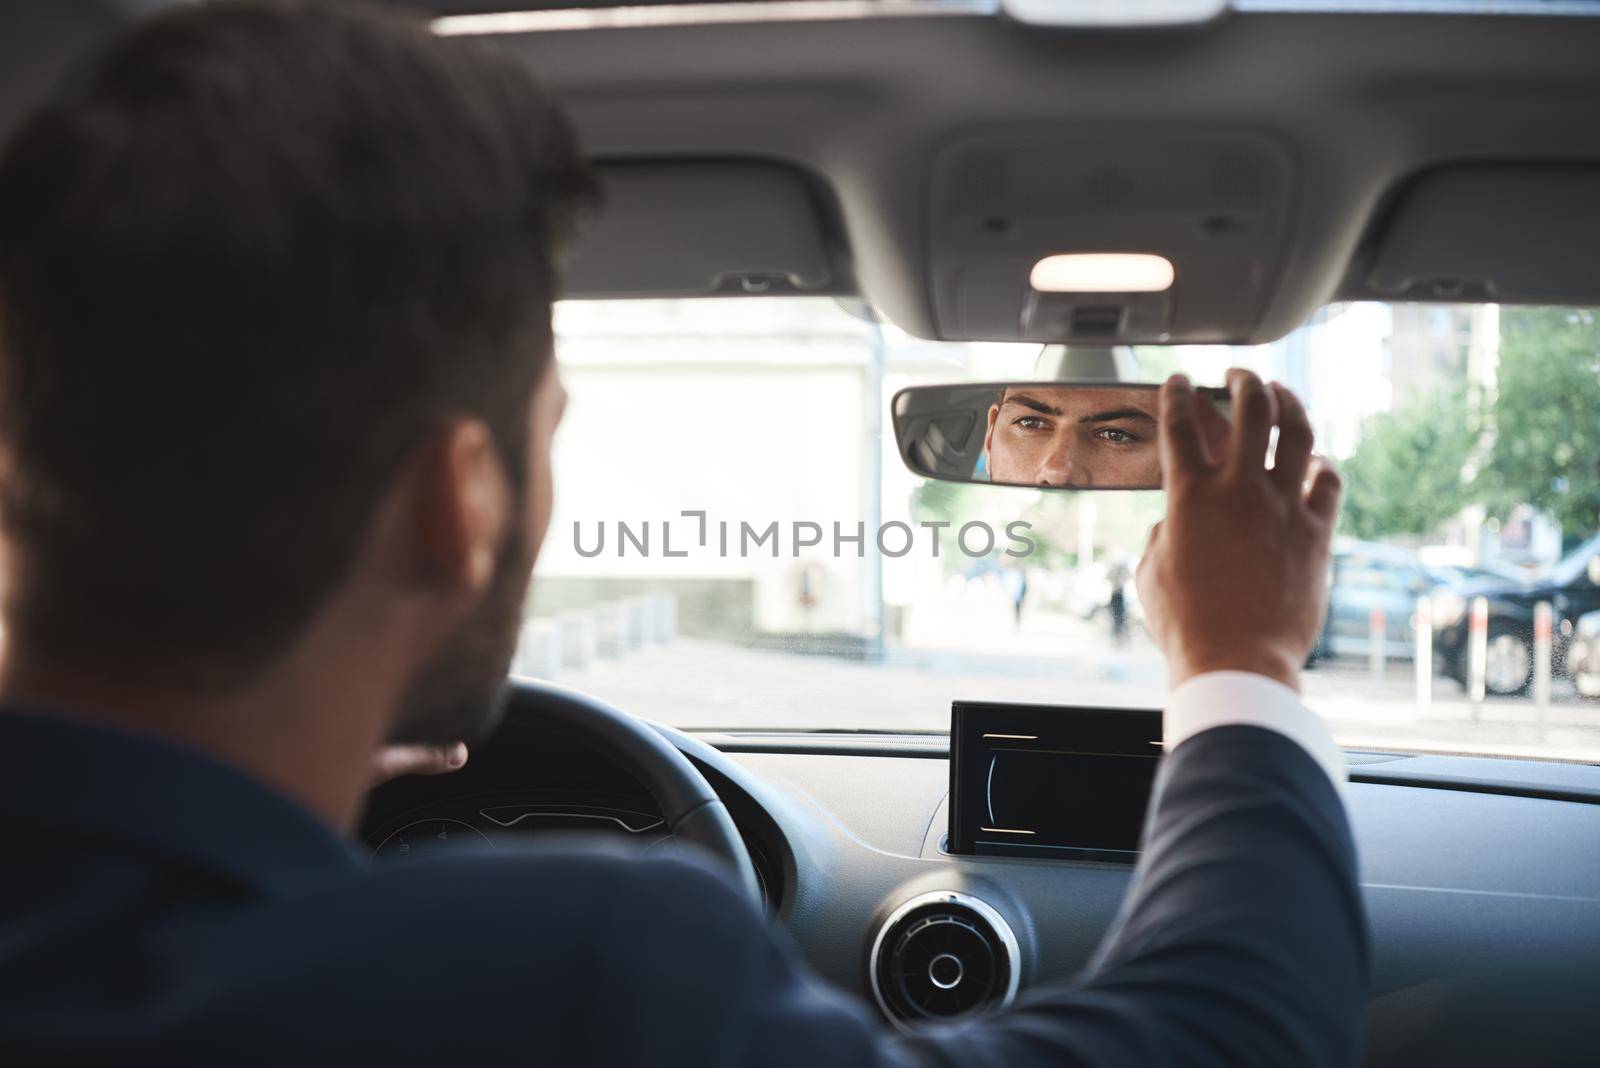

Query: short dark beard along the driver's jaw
[389,505,531,745]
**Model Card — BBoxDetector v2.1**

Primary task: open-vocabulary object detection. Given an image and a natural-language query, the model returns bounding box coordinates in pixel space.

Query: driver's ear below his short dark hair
[413,419,510,593]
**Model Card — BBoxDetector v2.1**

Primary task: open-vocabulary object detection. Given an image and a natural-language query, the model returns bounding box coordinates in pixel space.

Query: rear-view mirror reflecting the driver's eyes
[891,382,1227,489]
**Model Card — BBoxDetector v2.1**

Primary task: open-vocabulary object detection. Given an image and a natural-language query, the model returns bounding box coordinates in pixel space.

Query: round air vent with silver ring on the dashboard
[867,891,1021,1025]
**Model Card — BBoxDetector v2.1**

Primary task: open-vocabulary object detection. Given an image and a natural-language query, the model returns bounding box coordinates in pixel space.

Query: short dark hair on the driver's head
[0,3,597,684]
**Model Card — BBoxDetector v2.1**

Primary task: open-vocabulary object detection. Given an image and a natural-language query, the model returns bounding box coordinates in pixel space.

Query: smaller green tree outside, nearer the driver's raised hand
[1341,392,1478,539]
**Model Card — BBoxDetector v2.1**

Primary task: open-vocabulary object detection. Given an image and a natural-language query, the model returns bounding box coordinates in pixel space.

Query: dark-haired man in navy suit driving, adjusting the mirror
[0,3,1365,1066]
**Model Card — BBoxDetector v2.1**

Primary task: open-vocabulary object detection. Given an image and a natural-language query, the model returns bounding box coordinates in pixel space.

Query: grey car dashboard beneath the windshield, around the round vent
[363,705,1600,1061]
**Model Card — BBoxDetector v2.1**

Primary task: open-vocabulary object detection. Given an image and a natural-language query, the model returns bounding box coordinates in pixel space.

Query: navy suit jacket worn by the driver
[0,713,1366,1068]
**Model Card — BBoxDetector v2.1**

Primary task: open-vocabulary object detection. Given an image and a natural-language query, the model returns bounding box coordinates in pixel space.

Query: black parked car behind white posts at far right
[1434,534,1600,695]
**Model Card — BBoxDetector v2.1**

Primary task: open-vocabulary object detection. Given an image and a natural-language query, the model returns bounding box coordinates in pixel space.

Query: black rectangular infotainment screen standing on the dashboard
[949,700,1162,862]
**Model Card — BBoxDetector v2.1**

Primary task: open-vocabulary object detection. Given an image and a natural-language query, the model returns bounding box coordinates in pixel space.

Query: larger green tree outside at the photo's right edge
[1485,307,1600,536]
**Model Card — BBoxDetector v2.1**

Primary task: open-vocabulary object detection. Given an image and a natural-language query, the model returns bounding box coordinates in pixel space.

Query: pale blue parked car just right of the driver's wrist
[1312,540,1461,660]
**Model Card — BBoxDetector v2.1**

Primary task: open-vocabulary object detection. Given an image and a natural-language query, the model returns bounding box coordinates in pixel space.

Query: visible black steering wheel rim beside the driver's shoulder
[506,678,762,902]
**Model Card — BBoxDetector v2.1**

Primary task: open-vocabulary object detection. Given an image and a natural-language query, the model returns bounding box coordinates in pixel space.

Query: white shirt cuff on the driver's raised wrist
[1163,671,1346,799]
